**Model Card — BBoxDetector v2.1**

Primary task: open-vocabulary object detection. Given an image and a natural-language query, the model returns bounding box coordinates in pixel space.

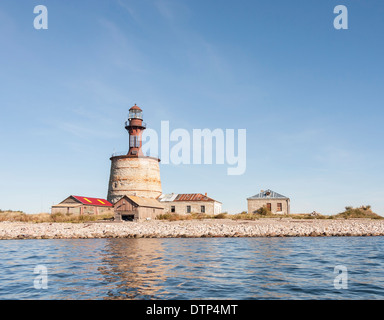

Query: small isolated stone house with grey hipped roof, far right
[247,189,290,214]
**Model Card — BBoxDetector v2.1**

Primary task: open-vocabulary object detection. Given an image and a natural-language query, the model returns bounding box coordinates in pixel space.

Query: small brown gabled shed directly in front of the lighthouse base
[114,195,164,221]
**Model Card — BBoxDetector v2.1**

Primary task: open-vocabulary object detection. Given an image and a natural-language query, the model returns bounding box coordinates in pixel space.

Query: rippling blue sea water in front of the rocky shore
[0,237,384,299]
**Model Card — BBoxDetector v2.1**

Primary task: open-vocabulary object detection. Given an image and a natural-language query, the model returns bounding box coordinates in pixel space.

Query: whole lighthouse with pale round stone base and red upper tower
[107,104,162,203]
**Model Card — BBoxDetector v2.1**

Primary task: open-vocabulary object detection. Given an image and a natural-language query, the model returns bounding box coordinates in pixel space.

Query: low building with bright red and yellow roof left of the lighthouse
[51,195,113,215]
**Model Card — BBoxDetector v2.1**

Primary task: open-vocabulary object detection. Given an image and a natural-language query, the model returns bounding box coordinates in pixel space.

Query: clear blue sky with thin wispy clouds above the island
[0,0,384,215]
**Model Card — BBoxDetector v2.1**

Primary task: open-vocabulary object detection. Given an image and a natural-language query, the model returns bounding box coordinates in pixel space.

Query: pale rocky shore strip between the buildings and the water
[0,218,384,240]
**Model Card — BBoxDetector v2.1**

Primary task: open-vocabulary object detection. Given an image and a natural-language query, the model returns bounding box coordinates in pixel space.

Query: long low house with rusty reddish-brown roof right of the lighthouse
[157,193,222,215]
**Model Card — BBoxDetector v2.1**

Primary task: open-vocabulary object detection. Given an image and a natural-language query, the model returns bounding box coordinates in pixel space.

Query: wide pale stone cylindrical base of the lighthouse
[107,156,161,203]
